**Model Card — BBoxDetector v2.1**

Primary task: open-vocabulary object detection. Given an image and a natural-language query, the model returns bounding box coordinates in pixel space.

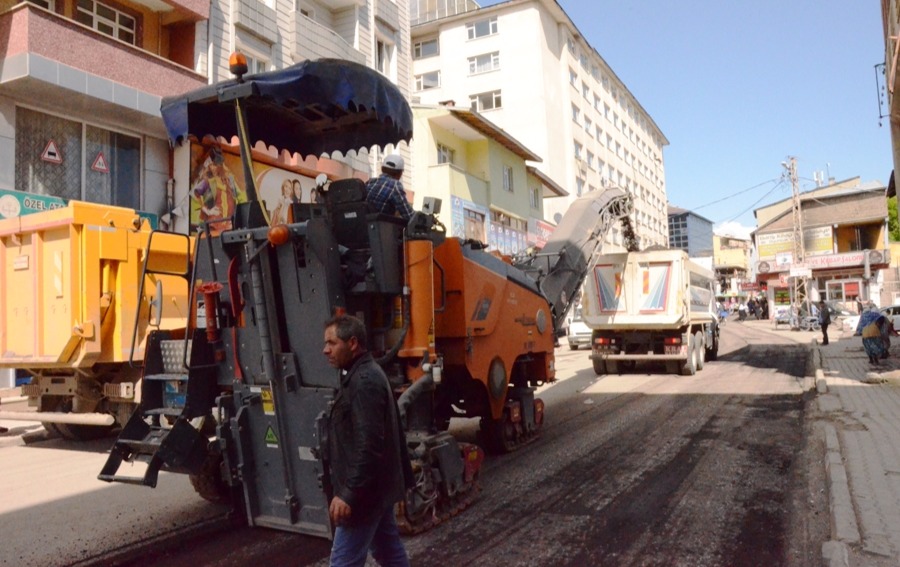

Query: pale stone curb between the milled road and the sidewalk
[813,345,861,567]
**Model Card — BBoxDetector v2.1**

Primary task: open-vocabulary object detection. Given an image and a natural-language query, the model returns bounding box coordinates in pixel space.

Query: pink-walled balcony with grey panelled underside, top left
[0,4,206,135]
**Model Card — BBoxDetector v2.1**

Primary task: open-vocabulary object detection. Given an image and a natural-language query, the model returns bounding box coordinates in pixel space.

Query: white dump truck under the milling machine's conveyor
[582,249,719,375]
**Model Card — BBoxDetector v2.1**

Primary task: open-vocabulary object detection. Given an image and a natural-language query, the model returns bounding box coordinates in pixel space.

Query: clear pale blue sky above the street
[479,0,893,240]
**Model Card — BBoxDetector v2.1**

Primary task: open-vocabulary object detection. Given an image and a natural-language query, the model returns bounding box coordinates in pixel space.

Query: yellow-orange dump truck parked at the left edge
[0,201,192,439]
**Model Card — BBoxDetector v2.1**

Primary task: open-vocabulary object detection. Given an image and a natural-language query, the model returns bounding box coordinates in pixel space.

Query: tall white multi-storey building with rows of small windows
[411,0,668,251]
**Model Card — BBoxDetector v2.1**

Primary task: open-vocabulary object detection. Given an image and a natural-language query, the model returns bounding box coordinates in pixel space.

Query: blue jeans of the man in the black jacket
[331,506,409,567]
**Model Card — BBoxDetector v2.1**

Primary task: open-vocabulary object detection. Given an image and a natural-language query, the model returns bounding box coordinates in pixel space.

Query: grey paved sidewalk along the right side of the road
[743,321,900,567]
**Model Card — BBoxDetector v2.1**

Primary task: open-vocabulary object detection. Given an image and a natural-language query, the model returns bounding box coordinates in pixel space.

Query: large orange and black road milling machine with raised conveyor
[99,59,632,538]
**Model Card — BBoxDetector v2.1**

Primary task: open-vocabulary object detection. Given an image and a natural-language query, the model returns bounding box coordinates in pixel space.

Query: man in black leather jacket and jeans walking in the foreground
[323,315,412,566]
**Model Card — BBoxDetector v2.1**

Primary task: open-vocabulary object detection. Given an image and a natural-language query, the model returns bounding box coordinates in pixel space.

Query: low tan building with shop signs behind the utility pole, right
[753,178,891,315]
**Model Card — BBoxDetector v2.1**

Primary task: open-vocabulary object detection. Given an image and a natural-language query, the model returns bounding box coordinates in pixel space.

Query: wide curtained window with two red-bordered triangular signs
[15,108,141,209]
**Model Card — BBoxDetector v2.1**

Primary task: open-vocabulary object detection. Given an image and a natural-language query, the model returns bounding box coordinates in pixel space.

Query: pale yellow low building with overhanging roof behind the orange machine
[412,105,565,254]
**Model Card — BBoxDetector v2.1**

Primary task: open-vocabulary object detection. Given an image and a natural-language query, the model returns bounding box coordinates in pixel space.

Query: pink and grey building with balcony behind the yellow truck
[0,0,209,223]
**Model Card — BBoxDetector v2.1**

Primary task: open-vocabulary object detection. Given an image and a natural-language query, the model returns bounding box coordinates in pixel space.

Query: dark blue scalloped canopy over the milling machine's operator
[161,59,412,156]
